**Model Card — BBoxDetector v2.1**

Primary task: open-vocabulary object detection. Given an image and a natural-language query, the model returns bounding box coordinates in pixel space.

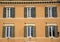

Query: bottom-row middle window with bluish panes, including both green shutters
[24,24,36,37]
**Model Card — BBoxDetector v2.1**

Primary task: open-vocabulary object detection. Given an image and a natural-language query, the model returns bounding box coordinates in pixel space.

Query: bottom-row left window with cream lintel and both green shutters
[3,24,15,38]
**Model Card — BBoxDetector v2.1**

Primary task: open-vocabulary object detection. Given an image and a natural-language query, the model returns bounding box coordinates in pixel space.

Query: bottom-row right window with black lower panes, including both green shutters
[45,25,58,37]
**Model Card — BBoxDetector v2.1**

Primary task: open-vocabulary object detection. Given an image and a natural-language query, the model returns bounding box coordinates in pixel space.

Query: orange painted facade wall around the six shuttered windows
[0,4,60,42]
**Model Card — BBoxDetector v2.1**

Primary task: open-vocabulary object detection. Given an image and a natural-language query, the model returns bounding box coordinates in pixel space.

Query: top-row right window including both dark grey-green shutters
[45,7,57,17]
